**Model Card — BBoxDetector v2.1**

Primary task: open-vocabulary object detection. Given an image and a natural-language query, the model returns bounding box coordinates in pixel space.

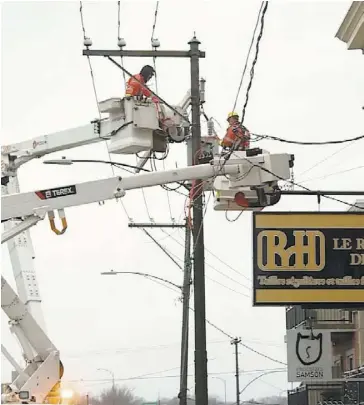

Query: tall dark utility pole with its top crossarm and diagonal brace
[82,36,208,405]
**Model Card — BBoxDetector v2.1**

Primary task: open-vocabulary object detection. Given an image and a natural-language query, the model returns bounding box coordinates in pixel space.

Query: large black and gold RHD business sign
[253,212,364,307]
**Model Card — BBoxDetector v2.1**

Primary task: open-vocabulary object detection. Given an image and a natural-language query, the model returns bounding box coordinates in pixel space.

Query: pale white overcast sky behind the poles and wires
[1,0,364,400]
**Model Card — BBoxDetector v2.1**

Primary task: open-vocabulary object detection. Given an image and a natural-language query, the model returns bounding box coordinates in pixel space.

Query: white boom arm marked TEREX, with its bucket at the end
[1,152,292,235]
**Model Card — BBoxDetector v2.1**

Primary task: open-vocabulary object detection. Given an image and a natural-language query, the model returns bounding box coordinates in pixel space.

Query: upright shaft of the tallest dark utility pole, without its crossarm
[189,36,208,405]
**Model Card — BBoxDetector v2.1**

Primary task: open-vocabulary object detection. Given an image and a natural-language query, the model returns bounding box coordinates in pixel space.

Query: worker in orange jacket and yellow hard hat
[220,111,250,150]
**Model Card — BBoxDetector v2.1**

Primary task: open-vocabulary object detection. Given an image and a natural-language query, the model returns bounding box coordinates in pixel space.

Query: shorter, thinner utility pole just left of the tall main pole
[179,219,192,405]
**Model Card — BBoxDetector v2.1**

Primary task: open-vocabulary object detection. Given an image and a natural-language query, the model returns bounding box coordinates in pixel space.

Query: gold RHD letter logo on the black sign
[257,230,326,271]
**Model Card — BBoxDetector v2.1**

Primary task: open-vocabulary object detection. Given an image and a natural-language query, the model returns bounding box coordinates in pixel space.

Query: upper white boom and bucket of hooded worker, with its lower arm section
[1,94,193,400]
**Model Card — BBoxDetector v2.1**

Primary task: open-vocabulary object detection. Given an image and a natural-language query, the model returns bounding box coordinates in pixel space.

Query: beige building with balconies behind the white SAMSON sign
[286,200,364,405]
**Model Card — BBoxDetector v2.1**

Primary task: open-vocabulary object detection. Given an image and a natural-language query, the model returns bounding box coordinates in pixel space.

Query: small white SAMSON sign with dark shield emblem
[287,329,332,382]
